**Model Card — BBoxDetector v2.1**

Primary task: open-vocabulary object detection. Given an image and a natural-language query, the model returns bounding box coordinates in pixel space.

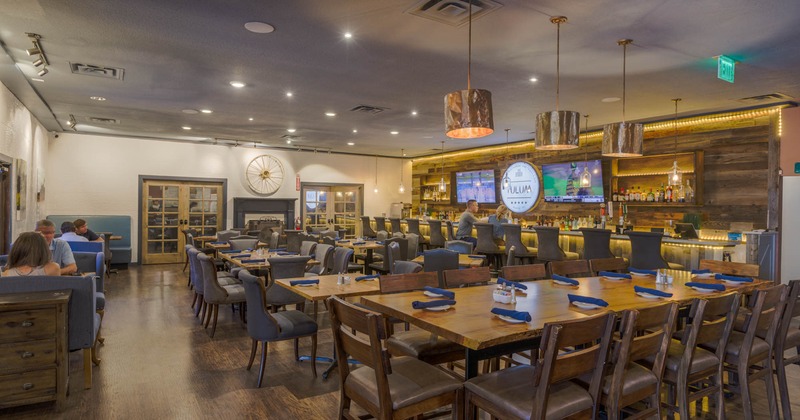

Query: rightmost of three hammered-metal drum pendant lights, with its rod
[603,39,644,157]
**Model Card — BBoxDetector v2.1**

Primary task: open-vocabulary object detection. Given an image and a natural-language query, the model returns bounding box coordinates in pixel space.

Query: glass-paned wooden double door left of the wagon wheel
[140,180,225,264]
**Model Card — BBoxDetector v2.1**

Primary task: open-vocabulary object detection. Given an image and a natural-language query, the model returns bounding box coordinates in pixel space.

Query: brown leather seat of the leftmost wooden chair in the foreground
[344,357,461,410]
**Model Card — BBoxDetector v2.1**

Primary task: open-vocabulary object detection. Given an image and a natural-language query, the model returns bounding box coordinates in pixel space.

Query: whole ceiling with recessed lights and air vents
[0,0,800,156]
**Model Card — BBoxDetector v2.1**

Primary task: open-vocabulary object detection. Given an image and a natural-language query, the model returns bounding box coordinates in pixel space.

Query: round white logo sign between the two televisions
[500,162,542,213]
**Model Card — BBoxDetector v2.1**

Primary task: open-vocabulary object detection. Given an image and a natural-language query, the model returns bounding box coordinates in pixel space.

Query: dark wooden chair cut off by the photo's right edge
[774,280,800,420]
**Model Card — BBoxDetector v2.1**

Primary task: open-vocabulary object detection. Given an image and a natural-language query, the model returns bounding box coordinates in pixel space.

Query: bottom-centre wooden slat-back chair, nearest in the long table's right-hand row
[464,312,615,420]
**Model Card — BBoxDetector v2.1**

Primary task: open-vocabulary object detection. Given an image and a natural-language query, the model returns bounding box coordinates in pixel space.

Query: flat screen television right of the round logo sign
[542,160,604,203]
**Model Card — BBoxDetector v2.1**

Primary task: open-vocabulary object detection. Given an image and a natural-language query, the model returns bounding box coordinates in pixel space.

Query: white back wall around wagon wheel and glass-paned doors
[46,133,411,261]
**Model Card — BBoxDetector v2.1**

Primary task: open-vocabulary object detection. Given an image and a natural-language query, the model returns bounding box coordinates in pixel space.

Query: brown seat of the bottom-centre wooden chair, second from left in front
[464,365,592,419]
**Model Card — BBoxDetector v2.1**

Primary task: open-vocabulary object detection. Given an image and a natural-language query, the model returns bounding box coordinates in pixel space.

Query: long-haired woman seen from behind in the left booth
[3,232,61,276]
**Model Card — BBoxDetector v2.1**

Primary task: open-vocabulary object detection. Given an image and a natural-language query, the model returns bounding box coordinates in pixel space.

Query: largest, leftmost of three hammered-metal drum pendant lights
[444,0,494,139]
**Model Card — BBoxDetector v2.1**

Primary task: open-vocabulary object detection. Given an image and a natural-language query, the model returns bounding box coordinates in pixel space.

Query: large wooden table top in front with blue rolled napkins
[361,270,772,350]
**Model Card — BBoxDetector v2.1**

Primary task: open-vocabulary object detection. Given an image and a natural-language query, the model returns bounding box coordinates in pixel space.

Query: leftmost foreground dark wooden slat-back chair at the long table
[328,296,463,420]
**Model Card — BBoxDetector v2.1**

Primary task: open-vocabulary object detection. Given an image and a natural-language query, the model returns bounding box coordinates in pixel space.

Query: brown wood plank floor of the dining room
[0,264,800,420]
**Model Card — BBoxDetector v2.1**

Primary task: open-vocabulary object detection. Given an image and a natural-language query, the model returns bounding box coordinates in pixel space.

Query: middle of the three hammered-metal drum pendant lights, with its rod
[535,16,581,150]
